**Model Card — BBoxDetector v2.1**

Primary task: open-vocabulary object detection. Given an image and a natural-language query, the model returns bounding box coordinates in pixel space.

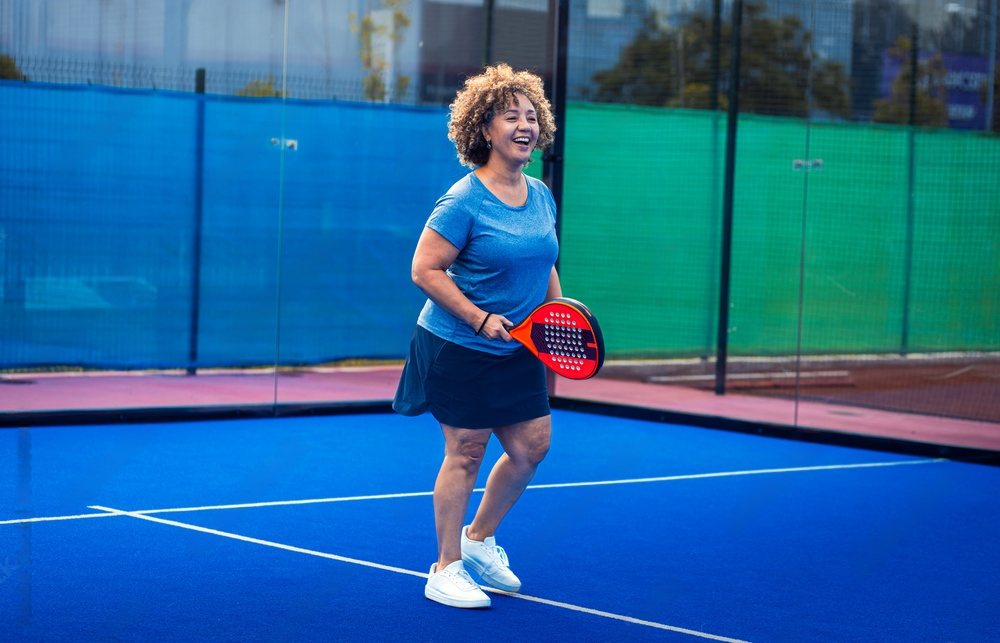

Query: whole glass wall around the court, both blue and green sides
[0,0,1000,446]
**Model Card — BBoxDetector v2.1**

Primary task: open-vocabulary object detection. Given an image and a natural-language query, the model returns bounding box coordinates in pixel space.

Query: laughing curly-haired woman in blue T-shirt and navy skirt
[393,64,562,607]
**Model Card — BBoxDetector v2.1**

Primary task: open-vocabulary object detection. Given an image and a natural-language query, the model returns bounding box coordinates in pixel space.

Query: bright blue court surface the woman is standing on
[0,411,1000,643]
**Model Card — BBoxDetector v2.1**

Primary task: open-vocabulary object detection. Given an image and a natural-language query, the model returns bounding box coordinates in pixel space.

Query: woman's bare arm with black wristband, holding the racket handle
[411,228,510,341]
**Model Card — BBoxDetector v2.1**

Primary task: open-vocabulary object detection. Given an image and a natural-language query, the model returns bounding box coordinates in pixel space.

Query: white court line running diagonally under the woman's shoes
[87,505,747,643]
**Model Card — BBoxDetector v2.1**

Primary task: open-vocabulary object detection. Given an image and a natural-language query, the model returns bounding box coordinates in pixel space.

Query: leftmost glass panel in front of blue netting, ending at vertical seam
[0,0,284,412]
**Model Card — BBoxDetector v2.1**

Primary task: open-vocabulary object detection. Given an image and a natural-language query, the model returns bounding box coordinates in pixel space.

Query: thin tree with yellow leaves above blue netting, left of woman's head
[348,0,412,102]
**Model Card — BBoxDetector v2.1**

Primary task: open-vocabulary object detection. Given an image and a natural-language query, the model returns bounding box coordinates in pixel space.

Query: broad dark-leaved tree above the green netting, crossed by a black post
[594,4,850,117]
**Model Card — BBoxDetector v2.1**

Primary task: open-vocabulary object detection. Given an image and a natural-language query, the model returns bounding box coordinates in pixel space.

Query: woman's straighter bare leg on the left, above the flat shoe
[434,424,492,570]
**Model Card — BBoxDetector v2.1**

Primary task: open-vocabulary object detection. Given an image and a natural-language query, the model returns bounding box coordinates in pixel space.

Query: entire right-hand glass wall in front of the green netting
[560,0,1000,448]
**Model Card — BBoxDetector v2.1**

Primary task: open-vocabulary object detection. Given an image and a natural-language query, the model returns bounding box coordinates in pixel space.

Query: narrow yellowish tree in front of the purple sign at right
[872,36,948,127]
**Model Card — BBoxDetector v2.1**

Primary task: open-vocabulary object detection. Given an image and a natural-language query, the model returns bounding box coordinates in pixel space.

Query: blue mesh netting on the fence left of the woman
[0,82,464,369]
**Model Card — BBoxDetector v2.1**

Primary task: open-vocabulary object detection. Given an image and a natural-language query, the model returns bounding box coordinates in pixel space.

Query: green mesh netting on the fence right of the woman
[561,104,1000,357]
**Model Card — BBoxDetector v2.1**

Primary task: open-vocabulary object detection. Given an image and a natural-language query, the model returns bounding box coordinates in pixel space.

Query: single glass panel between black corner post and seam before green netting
[563,1,816,424]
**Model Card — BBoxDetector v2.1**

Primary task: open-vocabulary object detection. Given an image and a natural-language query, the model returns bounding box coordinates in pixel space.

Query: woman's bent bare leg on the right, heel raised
[459,415,552,540]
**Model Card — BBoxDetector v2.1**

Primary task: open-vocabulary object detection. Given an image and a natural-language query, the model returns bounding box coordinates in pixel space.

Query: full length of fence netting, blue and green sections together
[0,81,1000,371]
